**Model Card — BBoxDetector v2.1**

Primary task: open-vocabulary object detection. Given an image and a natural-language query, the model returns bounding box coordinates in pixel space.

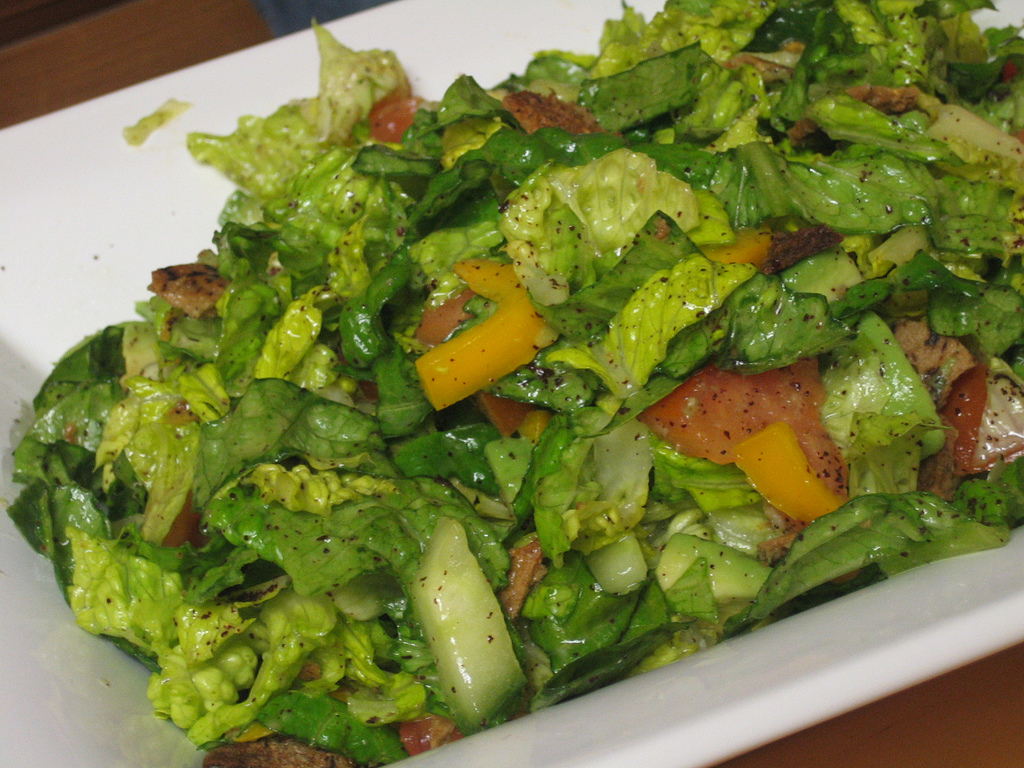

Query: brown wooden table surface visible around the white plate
[0,0,1024,768]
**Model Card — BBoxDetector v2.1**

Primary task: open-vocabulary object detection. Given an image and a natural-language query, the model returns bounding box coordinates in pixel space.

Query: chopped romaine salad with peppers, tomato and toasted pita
[9,2,1024,766]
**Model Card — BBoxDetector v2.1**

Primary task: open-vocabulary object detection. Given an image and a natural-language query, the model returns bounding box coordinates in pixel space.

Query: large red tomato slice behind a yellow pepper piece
[640,360,847,495]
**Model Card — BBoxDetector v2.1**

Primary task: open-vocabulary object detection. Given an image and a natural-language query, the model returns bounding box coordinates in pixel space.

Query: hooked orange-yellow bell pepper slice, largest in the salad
[416,259,556,411]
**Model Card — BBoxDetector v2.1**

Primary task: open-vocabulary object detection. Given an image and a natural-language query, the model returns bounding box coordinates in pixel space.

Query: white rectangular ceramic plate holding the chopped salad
[0,0,1024,768]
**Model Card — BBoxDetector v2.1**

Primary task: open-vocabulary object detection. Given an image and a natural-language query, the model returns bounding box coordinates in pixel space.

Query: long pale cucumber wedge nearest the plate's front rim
[411,517,526,734]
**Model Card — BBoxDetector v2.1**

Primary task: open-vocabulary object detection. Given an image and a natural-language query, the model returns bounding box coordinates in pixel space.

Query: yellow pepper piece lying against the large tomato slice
[733,421,846,522]
